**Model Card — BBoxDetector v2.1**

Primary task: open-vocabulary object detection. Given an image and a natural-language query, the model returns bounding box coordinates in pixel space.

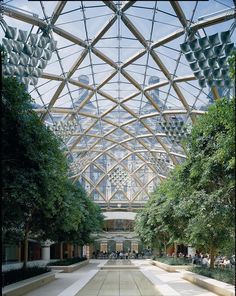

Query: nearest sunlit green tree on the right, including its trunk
[184,98,235,267]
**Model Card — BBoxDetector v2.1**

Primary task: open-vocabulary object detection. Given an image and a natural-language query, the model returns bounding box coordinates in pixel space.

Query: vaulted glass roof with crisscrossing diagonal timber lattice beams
[0,0,235,209]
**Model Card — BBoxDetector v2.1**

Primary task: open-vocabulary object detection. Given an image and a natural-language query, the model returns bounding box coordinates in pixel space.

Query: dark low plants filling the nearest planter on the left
[2,266,50,287]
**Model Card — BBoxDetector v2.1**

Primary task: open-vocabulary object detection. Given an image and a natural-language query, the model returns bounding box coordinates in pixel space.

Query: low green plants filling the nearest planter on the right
[189,266,235,285]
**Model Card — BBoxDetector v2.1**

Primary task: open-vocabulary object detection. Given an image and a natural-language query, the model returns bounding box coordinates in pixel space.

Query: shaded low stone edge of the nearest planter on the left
[2,271,55,296]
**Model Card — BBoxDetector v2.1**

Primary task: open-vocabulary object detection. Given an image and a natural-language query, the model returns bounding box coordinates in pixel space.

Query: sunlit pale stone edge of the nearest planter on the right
[182,271,235,296]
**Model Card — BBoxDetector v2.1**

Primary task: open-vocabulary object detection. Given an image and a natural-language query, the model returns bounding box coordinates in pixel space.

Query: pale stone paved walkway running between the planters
[24,260,216,296]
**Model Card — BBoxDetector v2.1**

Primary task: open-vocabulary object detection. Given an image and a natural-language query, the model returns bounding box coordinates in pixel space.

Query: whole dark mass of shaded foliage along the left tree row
[1,78,103,254]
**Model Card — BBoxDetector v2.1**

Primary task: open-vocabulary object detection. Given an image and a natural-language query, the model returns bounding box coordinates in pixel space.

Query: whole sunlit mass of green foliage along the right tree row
[135,73,235,262]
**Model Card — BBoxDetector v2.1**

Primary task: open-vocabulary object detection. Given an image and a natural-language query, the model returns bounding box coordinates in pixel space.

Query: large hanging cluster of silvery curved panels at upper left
[2,25,57,86]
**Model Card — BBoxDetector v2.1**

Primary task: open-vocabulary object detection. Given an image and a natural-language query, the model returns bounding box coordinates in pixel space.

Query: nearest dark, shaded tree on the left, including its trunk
[1,78,67,268]
